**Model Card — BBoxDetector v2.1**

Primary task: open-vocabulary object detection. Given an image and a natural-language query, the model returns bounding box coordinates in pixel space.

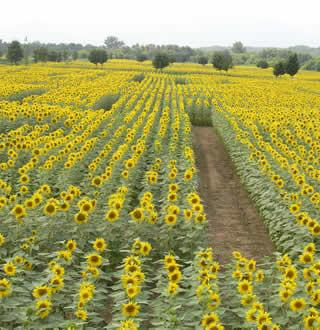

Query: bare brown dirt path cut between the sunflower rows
[193,127,273,263]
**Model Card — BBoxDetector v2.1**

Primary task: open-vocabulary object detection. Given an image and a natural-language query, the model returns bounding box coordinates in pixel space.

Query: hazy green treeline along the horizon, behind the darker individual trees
[0,36,320,71]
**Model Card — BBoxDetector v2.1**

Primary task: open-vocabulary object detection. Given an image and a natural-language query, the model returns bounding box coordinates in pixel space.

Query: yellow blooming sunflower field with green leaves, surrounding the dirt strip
[0,60,320,330]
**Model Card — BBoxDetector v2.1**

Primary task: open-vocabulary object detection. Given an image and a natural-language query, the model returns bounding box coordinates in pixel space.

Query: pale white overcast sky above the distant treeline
[0,0,320,47]
